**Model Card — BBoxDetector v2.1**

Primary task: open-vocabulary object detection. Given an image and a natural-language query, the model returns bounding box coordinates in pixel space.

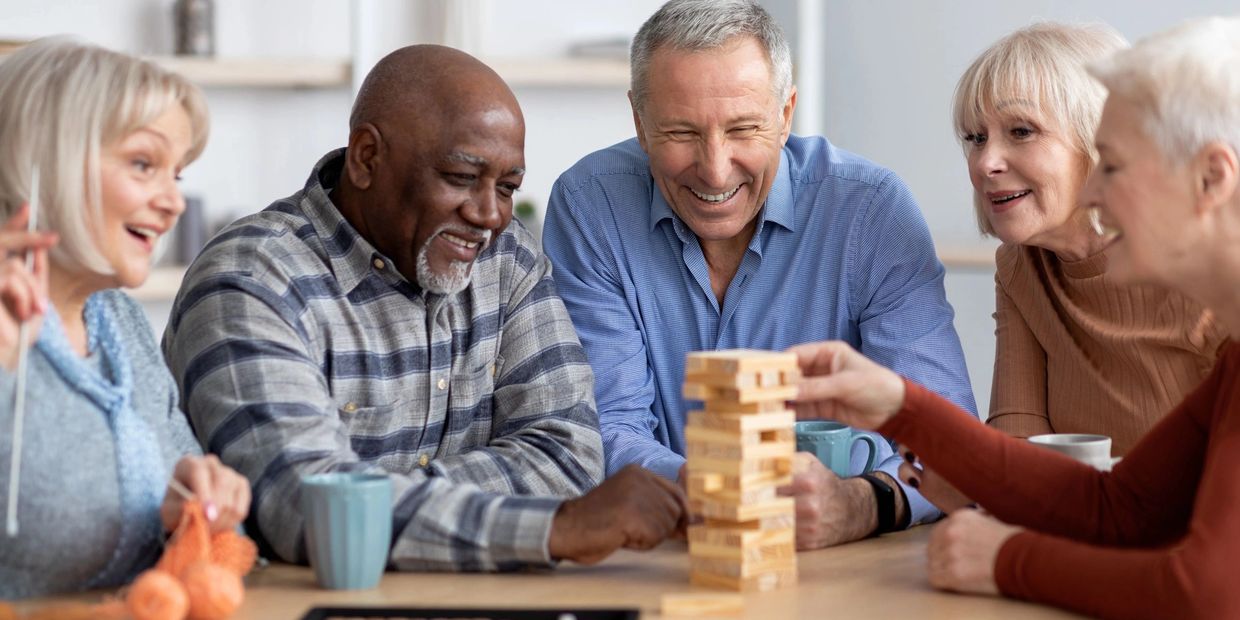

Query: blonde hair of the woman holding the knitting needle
[0,37,208,274]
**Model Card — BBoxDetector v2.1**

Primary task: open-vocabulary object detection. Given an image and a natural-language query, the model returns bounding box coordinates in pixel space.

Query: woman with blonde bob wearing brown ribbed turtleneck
[954,22,1224,455]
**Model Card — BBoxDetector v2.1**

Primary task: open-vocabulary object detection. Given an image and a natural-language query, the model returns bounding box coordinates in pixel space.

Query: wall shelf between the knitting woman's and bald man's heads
[149,56,353,88]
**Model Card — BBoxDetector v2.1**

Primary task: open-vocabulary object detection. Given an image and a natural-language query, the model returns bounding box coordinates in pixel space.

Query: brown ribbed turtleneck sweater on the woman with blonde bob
[987,244,1226,456]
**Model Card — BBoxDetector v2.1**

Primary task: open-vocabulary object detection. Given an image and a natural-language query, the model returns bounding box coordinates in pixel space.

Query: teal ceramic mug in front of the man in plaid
[301,472,392,590]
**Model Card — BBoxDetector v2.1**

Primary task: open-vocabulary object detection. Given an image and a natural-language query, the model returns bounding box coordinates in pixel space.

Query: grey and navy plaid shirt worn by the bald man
[164,150,603,570]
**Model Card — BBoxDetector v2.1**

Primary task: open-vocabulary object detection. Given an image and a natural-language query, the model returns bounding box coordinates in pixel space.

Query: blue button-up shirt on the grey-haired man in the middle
[543,136,977,523]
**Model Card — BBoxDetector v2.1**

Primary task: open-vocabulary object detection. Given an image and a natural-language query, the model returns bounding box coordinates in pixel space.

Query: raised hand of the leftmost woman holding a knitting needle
[0,206,57,371]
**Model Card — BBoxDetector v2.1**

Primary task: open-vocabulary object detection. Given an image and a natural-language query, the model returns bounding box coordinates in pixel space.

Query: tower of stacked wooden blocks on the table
[684,350,801,591]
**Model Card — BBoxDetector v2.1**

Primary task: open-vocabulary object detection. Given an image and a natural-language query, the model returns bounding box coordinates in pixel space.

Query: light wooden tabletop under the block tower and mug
[186,527,1074,620]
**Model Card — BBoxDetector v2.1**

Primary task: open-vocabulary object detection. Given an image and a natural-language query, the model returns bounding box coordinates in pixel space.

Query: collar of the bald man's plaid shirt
[301,149,404,294]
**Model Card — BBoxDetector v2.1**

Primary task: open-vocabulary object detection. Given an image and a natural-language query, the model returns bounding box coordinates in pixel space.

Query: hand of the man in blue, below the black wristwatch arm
[779,453,878,551]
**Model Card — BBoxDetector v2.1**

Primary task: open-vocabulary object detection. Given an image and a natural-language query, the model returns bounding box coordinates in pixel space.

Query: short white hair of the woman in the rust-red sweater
[1090,16,1240,162]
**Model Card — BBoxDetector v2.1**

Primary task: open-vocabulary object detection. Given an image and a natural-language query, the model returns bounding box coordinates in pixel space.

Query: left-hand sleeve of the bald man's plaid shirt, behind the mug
[165,248,559,570]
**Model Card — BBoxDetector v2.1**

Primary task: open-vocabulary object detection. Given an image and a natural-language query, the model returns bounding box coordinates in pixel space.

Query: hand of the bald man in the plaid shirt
[548,465,688,564]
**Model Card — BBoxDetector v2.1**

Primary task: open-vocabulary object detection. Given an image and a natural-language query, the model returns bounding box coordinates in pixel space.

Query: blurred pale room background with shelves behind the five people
[0,0,1240,415]
